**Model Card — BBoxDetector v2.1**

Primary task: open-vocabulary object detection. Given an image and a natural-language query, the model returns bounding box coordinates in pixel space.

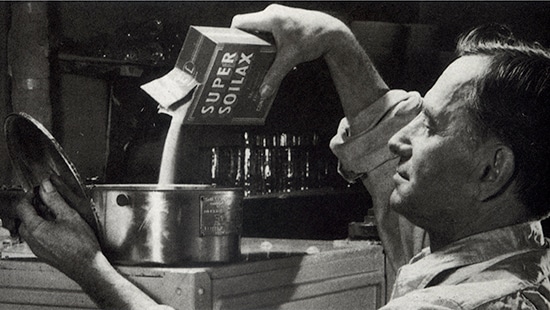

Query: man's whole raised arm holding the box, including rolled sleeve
[232,5,430,276]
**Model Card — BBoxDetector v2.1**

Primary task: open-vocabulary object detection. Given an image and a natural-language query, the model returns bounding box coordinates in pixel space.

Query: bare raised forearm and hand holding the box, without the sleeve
[232,5,388,130]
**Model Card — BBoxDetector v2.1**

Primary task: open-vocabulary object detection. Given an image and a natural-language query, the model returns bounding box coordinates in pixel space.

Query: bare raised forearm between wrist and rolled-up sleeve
[325,29,389,130]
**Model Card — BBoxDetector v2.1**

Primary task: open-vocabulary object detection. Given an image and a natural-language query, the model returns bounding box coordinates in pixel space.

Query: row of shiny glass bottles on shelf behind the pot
[203,132,339,196]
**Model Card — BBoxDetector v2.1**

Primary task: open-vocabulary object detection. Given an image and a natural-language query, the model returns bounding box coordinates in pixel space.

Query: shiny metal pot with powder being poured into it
[90,184,243,265]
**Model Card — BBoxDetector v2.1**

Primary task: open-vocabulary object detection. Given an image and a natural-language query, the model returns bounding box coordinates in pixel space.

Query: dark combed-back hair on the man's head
[457,25,550,219]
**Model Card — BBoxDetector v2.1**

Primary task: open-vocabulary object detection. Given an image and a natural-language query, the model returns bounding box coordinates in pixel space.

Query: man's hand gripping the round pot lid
[17,179,101,280]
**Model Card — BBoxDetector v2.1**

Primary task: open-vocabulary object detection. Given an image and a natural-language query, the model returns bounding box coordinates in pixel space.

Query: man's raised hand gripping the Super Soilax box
[231,4,353,98]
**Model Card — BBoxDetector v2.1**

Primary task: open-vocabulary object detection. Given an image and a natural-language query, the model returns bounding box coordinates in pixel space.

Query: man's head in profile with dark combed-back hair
[389,27,550,240]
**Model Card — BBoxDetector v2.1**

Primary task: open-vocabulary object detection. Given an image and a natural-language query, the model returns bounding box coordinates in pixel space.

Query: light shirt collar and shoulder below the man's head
[383,222,550,310]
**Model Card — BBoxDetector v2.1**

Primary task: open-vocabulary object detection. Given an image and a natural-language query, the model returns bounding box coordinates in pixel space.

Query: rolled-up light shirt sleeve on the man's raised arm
[330,90,429,285]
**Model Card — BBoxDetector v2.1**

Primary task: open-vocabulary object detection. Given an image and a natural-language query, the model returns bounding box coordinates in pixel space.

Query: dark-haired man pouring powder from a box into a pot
[18,5,550,309]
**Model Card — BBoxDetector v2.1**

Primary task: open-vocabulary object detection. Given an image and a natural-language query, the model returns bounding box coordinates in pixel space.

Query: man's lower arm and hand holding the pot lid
[17,180,171,309]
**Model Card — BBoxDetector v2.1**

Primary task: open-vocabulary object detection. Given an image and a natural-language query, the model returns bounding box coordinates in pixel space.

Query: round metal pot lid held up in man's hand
[4,112,97,231]
